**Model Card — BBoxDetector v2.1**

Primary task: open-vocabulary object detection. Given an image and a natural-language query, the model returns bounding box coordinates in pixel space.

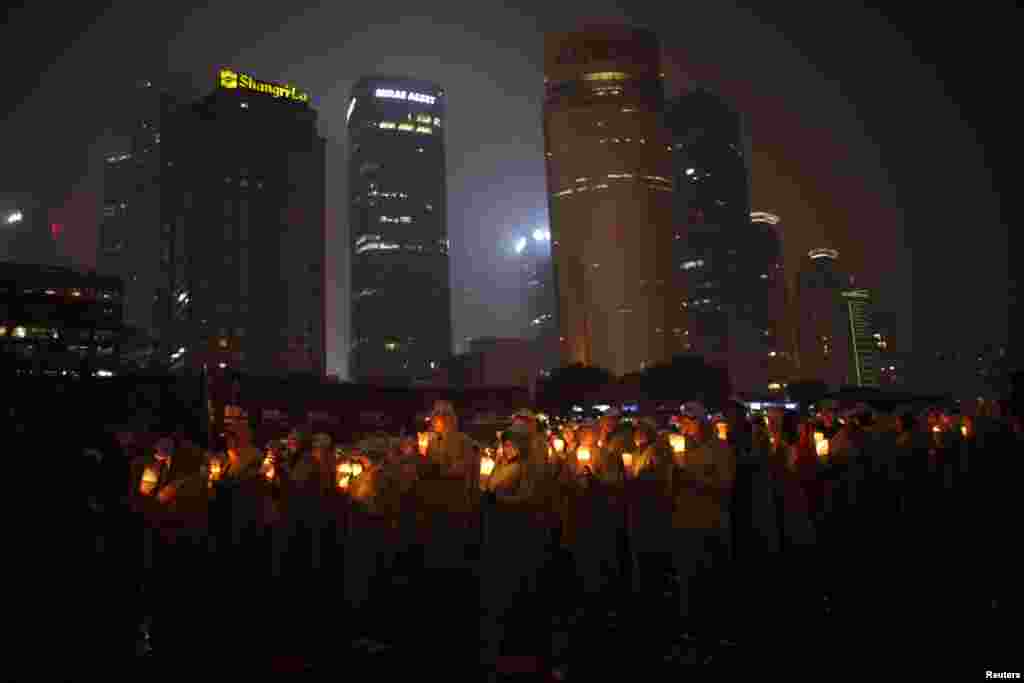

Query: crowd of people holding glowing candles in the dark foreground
[75,401,1022,677]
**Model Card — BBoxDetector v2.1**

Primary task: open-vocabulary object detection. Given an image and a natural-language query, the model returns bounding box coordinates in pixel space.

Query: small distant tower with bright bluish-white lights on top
[515,227,561,370]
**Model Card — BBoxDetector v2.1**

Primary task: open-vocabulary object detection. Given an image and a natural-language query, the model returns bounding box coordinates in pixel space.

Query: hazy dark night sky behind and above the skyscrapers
[0,0,1017,378]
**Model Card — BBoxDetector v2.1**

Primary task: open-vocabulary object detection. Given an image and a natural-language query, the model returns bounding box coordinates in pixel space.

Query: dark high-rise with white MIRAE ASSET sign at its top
[347,77,452,382]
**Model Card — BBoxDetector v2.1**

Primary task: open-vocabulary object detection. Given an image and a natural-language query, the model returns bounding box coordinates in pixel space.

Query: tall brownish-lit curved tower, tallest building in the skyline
[544,26,684,375]
